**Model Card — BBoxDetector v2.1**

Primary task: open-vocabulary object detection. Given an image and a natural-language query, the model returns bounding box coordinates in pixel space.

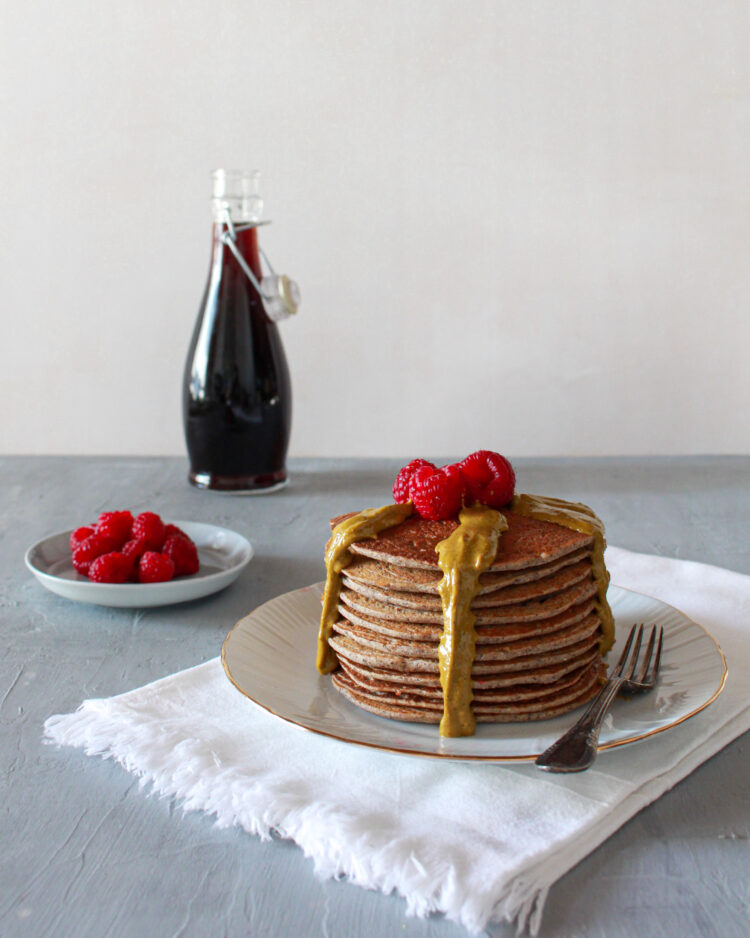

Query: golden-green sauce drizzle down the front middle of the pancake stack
[435,505,508,736]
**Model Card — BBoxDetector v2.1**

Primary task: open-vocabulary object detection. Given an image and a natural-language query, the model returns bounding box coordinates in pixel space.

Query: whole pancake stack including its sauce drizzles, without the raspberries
[319,486,612,736]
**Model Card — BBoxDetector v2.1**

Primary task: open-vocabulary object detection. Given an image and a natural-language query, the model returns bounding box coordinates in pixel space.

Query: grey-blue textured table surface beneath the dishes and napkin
[0,456,750,938]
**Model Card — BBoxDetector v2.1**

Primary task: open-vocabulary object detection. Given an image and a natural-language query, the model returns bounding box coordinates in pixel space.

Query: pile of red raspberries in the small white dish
[70,511,200,583]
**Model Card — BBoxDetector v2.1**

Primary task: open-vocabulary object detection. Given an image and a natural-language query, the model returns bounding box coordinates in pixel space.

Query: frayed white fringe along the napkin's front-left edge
[44,699,560,935]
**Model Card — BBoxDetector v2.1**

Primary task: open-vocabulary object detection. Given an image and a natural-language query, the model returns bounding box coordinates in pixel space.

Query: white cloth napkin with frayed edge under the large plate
[45,547,750,934]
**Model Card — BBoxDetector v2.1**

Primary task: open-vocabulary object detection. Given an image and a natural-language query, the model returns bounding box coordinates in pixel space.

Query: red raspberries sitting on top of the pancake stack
[393,449,516,521]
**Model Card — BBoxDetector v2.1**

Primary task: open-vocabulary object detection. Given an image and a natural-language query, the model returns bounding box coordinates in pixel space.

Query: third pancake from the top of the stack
[342,560,592,622]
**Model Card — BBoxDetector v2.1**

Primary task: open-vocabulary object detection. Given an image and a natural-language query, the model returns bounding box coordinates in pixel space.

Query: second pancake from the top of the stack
[344,548,589,596]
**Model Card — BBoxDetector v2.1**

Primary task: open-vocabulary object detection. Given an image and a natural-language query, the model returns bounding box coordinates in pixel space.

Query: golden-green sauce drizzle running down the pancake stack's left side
[316,502,414,674]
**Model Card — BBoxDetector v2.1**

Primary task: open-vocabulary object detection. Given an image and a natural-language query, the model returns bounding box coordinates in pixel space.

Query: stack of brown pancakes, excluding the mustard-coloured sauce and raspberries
[330,511,606,723]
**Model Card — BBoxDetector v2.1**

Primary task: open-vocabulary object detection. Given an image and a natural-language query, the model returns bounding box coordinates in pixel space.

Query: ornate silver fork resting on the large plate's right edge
[535,625,664,772]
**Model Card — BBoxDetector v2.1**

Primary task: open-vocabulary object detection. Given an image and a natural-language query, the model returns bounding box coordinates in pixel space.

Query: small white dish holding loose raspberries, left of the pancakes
[24,521,253,609]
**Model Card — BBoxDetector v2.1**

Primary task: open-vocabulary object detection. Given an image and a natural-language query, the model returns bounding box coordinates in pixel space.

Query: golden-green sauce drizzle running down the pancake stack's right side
[511,495,615,655]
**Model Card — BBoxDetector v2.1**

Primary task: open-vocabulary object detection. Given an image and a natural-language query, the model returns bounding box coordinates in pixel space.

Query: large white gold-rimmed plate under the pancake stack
[221,583,727,762]
